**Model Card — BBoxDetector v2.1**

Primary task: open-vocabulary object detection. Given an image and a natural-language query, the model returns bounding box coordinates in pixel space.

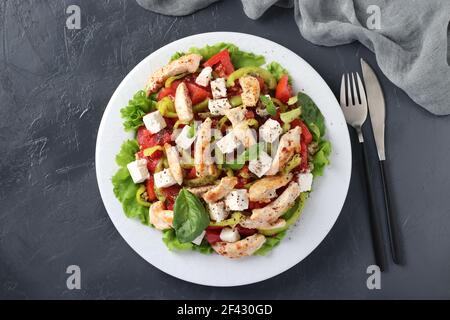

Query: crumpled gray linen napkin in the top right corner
[137,0,450,115]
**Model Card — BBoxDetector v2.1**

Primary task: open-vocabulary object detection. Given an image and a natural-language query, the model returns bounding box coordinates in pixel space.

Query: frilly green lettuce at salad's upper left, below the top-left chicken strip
[120,90,156,131]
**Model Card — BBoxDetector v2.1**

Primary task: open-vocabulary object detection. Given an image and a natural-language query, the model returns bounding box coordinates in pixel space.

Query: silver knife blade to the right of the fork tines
[361,59,386,161]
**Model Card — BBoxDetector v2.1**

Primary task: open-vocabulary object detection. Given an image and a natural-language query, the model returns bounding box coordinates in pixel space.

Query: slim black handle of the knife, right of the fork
[380,160,401,264]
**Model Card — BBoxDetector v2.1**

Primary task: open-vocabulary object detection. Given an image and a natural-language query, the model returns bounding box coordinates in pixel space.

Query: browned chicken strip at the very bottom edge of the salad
[211,233,266,259]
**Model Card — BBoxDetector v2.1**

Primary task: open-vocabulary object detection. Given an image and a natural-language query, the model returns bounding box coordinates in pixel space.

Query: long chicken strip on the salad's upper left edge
[147,54,203,96]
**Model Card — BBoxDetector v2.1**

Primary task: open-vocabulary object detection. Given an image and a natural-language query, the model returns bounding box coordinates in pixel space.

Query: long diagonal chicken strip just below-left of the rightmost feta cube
[250,182,300,223]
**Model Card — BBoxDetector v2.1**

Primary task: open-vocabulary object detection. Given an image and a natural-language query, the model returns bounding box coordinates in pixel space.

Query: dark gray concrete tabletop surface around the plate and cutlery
[0,0,450,299]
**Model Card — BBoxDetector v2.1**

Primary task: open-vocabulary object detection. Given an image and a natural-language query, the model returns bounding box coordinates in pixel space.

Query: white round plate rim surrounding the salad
[95,32,352,287]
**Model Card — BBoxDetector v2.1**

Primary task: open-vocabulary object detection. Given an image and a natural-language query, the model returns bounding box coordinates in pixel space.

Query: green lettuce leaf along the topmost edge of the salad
[185,42,266,69]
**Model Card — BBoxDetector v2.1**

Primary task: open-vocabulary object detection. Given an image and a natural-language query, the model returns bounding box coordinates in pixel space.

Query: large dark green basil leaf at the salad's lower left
[173,189,209,243]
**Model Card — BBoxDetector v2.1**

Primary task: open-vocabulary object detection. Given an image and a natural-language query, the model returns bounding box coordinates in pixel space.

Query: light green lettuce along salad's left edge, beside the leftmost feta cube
[112,140,149,225]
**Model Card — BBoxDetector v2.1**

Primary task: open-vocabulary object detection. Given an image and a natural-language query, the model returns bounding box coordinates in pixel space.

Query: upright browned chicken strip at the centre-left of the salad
[194,118,217,177]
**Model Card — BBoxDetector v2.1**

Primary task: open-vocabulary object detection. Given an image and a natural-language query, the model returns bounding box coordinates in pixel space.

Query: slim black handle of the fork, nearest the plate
[360,142,386,271]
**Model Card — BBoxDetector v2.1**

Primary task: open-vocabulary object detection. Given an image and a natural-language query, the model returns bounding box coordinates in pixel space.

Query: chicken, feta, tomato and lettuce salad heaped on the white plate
[112,43,331,258]
